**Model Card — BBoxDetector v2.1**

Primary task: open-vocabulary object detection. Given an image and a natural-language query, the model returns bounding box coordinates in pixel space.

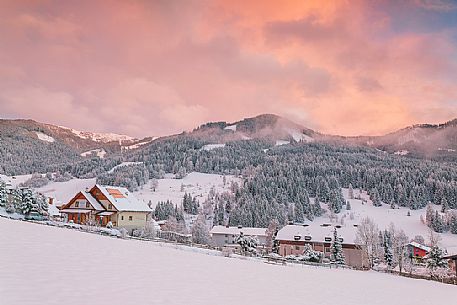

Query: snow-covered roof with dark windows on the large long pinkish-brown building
[276,222,357,244]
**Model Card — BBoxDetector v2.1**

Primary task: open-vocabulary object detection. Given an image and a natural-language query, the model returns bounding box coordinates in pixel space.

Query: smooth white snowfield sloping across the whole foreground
[0,218,457,305]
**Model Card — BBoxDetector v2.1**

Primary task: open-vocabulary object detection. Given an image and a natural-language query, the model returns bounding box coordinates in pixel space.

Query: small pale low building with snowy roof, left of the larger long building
[209,226,267,247]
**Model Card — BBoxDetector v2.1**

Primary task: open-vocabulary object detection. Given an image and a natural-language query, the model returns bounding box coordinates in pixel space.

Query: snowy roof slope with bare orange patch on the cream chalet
[96,184,152,212]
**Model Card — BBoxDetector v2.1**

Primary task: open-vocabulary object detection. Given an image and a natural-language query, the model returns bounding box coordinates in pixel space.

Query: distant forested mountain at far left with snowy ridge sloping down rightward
[0,119,151,175]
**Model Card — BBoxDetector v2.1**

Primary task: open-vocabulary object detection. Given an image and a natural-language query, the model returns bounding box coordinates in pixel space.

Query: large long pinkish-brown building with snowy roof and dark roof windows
[276,223,368,268]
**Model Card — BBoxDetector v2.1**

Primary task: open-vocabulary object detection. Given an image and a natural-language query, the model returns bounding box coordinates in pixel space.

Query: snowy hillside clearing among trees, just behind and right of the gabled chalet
[133,172,241,207]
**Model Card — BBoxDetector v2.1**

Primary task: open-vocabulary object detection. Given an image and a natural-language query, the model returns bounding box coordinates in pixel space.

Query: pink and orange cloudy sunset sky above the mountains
[0,0,457,137]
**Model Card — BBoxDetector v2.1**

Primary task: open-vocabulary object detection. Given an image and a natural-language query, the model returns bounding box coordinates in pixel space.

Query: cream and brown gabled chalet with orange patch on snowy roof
[59,184,152,230]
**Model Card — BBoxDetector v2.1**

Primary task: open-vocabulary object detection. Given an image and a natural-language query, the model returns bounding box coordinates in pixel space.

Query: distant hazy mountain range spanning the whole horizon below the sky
[0,114,457,177]
